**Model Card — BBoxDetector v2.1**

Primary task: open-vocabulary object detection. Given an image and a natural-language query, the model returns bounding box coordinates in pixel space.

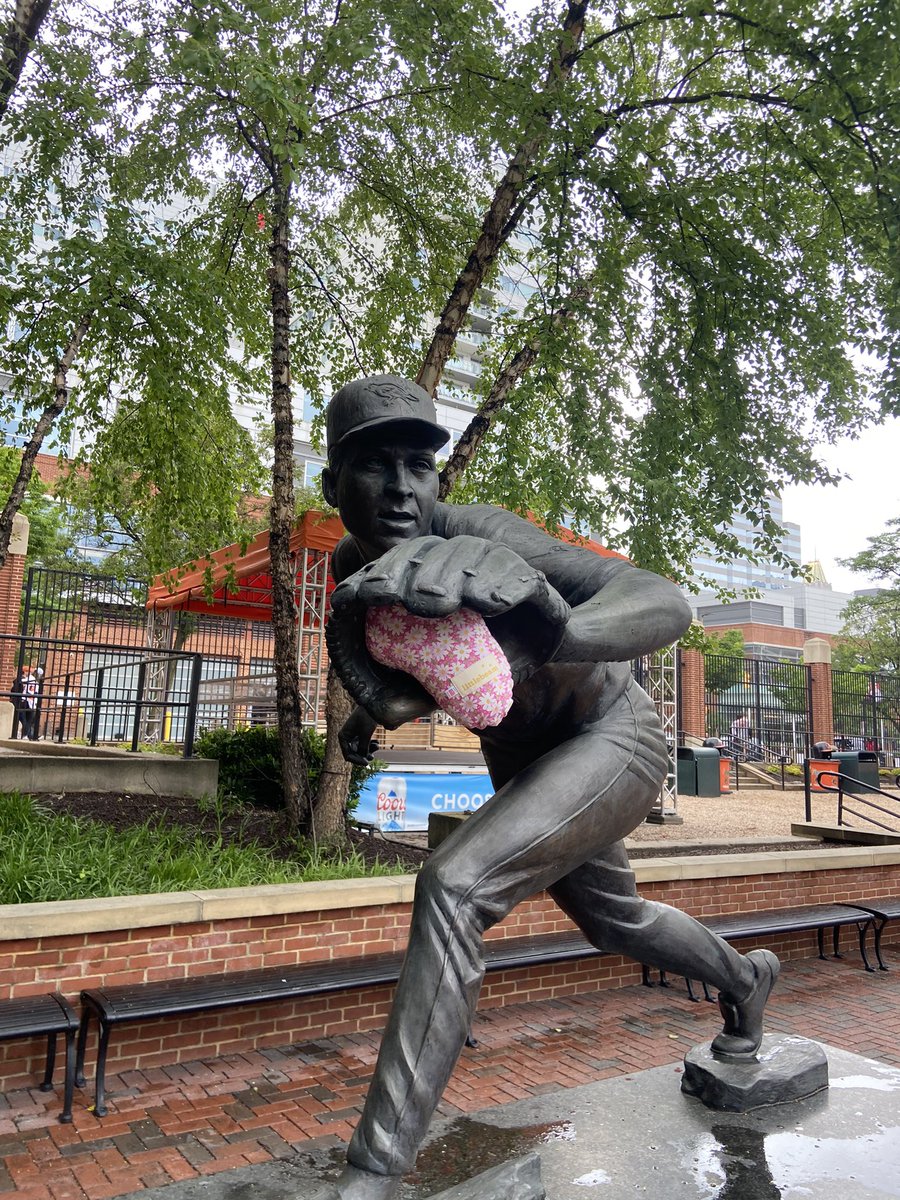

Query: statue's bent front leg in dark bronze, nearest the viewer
[348,688,681,1176]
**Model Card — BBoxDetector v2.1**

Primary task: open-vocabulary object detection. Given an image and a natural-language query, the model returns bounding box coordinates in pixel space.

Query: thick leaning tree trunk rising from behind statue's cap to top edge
[416,0,588,395]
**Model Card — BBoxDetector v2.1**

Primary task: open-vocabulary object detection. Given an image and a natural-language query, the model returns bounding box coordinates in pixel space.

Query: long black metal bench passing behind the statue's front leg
[74,932,600,1117]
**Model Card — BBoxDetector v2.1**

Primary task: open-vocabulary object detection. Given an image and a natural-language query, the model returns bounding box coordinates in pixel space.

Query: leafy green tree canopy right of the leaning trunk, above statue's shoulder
[432,2,900,582]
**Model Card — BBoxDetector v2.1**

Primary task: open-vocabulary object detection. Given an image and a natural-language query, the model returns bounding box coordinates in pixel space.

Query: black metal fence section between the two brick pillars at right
[706,654,812,762]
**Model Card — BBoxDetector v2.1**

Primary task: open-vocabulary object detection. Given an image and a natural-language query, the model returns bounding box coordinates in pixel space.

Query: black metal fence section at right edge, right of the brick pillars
[832,671,900,767]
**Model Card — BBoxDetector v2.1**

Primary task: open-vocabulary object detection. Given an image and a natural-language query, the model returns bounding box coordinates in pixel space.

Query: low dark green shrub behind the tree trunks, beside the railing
[194,725,379,812]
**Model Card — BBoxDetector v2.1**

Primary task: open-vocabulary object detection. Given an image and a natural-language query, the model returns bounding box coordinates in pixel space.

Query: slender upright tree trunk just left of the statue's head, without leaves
[269,163,310,832]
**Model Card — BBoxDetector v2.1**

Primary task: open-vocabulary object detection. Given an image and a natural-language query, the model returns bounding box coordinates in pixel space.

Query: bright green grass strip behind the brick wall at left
[0,792,403,904]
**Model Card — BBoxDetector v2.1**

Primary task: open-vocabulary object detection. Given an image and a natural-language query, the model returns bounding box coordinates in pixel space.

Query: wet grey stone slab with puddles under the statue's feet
[114,1046,900,1200]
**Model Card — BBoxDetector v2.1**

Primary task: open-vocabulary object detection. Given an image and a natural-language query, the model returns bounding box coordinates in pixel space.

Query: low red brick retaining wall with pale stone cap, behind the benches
[0,847,900,1091]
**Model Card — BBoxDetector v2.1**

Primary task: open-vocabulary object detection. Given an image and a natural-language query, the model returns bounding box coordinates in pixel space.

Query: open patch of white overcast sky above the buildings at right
[781,418,900,592]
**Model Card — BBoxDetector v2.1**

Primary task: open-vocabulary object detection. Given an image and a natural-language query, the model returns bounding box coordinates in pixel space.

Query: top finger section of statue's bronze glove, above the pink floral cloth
[331,534,569,625]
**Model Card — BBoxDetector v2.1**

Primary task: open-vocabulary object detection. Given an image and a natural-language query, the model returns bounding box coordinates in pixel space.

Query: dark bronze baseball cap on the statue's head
[325,376,450,457]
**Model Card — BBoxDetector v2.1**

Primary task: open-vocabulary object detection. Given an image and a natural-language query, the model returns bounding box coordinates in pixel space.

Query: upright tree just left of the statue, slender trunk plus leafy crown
[105,0,525,827]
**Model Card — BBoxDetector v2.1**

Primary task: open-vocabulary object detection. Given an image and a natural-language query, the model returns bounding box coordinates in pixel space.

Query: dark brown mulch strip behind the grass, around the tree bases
[34,792,428,871]
